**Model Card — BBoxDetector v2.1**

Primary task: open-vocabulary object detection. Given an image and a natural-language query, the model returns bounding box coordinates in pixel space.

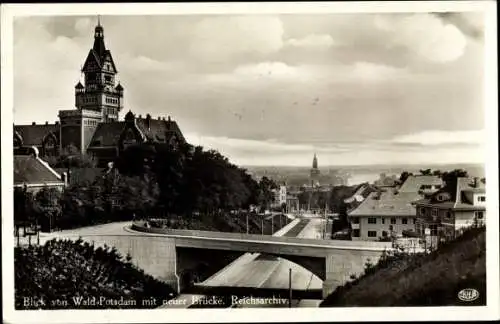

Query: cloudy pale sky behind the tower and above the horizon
[14,12,486,168]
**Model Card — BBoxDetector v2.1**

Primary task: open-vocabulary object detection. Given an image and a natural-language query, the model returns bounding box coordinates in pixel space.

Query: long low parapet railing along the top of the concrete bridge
[132,221,392,249]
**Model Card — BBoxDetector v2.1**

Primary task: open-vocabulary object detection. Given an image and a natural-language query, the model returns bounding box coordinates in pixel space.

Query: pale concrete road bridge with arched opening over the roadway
[47,223,391,296]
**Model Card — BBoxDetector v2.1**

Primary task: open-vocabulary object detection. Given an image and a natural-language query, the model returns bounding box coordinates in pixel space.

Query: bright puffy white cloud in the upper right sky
[375,14,467,63]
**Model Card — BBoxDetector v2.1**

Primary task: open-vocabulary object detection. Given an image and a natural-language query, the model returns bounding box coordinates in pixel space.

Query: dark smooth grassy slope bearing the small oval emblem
[321,228,486,307]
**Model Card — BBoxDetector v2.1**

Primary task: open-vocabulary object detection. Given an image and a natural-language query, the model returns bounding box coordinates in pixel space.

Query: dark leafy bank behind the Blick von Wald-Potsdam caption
[14,240,175,310]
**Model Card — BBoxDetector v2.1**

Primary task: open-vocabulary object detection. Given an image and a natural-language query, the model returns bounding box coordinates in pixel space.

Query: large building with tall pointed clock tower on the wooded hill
[13,22,185,165]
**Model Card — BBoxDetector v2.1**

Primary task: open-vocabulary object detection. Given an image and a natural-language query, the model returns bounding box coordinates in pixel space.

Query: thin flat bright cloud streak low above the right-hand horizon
[392,130,486,146]
